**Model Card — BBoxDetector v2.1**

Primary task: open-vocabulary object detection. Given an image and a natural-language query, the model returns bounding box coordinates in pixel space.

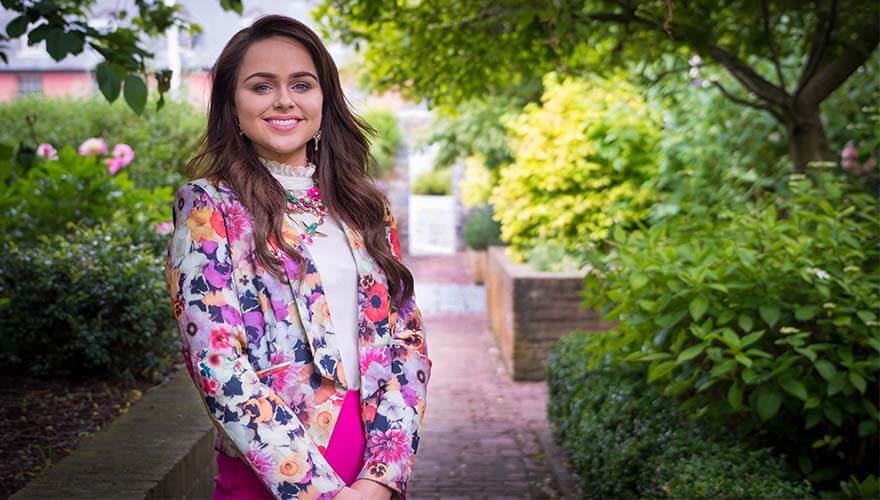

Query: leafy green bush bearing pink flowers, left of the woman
[0,146,172,243]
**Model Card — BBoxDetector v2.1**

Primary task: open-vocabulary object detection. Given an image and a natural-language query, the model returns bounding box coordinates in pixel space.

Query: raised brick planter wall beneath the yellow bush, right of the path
[485,247,613,380]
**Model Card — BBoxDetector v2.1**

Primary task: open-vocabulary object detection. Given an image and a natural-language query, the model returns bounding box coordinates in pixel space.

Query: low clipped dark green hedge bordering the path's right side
[547,333,809,498]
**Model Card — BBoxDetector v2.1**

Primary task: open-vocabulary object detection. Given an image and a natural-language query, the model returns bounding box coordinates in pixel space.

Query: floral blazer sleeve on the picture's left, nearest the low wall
[166,183,345,499]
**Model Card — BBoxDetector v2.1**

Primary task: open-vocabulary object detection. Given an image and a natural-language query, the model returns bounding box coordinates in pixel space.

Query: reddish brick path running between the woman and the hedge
[407,255,574,499]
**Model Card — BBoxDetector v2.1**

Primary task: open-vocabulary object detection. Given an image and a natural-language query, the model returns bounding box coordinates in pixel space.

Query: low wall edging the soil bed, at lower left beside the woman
[10,370,216,500]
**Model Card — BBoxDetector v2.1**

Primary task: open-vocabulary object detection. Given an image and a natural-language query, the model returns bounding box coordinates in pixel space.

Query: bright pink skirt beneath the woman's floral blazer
[212,389,366,500]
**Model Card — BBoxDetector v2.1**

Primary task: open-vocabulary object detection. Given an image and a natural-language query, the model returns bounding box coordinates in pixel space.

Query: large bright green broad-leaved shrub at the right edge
[584,171,880,487]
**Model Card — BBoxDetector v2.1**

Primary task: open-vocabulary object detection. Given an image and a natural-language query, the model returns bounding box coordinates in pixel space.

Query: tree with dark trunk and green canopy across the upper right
[315,0,880,172]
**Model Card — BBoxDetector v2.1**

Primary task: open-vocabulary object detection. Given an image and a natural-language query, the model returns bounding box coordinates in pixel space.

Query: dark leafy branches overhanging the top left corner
[0,0,242,114]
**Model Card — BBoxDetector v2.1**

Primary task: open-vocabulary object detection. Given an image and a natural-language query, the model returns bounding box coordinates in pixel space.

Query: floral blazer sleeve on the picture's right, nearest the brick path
[358,204,433,499]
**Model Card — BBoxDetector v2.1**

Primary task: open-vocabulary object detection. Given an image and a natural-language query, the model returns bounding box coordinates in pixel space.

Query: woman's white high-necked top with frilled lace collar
[260,158,361,389]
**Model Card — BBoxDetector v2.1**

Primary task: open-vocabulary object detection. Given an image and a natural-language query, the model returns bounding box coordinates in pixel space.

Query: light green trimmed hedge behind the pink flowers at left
[0,96,205,188]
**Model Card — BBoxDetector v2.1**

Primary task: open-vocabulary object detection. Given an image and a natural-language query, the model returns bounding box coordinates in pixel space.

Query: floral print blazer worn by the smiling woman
[165,179,432,499]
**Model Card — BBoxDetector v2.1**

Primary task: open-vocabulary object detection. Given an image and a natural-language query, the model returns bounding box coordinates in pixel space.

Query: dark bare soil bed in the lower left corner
[0,375,165,500]
